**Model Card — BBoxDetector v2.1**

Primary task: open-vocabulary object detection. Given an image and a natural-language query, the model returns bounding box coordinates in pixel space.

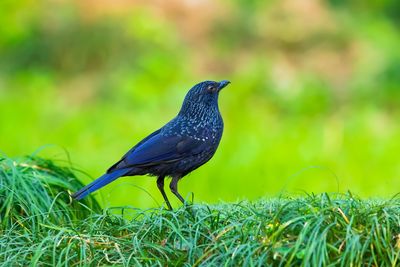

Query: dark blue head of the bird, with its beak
[185,80,230,104]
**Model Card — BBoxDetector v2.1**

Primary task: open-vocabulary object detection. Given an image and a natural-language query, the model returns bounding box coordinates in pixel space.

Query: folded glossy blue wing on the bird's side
[110,134,209,171]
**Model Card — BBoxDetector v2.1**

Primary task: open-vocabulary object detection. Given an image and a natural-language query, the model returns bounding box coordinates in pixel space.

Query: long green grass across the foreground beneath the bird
[0,157,400,266]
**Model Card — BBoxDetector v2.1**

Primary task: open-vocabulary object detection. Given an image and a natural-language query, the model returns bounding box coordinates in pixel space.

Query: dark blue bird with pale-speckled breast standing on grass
[71,80,230,210]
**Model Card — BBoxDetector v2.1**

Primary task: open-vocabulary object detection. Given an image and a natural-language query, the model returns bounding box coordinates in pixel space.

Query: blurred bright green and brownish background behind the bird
[0,0,400,207]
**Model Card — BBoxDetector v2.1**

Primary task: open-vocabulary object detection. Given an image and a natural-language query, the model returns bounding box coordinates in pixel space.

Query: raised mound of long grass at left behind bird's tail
[0,157,100,233]
